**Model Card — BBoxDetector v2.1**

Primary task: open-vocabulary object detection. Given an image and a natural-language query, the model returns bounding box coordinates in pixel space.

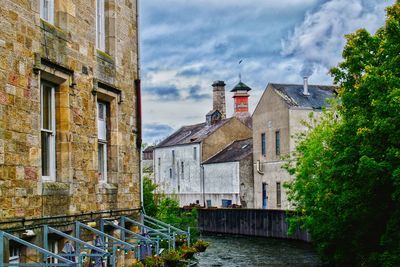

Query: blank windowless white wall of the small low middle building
[204,162,240,207]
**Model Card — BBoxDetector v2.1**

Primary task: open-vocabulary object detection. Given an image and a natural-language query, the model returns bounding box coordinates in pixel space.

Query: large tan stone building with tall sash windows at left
[0,0,141,264]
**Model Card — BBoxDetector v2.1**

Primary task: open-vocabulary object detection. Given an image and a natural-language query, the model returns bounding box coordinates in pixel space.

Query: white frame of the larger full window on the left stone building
[40,81,56,181]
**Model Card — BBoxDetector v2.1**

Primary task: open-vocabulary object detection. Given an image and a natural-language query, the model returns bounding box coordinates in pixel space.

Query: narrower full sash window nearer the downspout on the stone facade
[97,102,108,183]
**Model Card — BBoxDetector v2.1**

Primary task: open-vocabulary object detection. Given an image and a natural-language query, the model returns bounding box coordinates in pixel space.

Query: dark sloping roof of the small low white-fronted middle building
[203,138,253,164]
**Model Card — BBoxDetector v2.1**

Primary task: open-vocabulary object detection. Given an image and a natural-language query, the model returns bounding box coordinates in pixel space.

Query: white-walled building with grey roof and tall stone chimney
[154,81,252,206]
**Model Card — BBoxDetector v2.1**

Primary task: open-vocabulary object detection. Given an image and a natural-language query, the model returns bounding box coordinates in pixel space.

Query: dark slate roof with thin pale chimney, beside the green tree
[270,83,335,109]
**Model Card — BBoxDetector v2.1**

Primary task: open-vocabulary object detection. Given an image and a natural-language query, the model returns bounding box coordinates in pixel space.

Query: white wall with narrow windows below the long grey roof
[154,143,202,206]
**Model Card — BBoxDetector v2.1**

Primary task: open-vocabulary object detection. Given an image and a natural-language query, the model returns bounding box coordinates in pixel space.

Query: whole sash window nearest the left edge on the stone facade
[40,81,56,181]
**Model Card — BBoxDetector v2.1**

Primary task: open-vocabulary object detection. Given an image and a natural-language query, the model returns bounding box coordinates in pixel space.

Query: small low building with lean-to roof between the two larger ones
[203,138,254,208]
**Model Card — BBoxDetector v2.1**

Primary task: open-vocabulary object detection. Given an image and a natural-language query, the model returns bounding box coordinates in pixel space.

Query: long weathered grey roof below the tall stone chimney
[156,118,232,148]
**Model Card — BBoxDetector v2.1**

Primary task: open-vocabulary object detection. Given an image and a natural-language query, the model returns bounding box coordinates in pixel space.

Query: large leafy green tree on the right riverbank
[288,0,400,266]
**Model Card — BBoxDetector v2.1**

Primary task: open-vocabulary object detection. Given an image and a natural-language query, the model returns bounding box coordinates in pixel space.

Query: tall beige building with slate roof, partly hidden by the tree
[252,79,334,210]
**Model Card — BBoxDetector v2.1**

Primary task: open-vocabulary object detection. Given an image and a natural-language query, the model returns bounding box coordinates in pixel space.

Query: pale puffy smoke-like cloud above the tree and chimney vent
[282,0,394,75]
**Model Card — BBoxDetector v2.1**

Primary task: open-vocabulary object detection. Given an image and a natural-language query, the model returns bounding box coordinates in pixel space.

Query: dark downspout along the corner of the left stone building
[135,0,144,212]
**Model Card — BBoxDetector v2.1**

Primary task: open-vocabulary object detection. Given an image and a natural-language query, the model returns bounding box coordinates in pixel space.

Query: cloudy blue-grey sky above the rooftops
[139,0,394,144]
